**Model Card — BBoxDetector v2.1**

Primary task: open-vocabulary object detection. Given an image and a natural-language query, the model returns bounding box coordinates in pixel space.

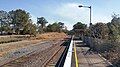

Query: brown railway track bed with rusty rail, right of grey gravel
[0,41,69,67]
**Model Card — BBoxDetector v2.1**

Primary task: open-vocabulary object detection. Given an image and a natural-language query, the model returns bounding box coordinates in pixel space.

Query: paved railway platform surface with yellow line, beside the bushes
[71,40,113,67]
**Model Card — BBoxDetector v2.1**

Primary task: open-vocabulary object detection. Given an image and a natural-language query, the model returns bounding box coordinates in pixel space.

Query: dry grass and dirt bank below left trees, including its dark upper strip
[0,33,66,56]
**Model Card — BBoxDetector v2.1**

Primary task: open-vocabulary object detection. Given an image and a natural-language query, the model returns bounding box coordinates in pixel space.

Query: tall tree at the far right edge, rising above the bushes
[107,14,120,41]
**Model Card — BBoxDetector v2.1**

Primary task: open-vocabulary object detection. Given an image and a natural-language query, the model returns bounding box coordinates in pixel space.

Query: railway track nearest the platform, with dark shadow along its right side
[43,40,69,67]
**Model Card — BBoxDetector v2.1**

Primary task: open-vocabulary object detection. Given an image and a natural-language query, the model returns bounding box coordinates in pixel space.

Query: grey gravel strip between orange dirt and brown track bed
[0,41,51,66]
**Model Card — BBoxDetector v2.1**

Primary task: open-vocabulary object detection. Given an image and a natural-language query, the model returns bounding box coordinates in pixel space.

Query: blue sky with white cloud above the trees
[0,0,120,30]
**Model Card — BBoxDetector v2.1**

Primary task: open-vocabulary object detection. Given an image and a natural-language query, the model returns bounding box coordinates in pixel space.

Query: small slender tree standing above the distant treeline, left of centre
[37,17,48,32]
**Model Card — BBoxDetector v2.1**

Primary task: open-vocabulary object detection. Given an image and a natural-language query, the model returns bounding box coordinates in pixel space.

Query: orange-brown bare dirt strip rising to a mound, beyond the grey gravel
[0,32,66,57]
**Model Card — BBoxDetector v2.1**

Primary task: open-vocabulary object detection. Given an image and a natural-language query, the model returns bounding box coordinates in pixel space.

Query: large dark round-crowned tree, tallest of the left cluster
[9,9,30,34]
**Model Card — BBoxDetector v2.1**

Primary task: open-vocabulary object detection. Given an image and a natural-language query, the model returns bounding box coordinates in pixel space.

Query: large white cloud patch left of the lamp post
[54,3,89,29]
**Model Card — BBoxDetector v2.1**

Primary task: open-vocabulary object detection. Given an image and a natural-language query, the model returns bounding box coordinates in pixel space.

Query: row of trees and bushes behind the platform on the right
[69,14,120,40]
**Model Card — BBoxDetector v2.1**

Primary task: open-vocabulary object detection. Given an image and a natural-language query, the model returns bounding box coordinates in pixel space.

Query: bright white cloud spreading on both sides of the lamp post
[54,3,111,30]
